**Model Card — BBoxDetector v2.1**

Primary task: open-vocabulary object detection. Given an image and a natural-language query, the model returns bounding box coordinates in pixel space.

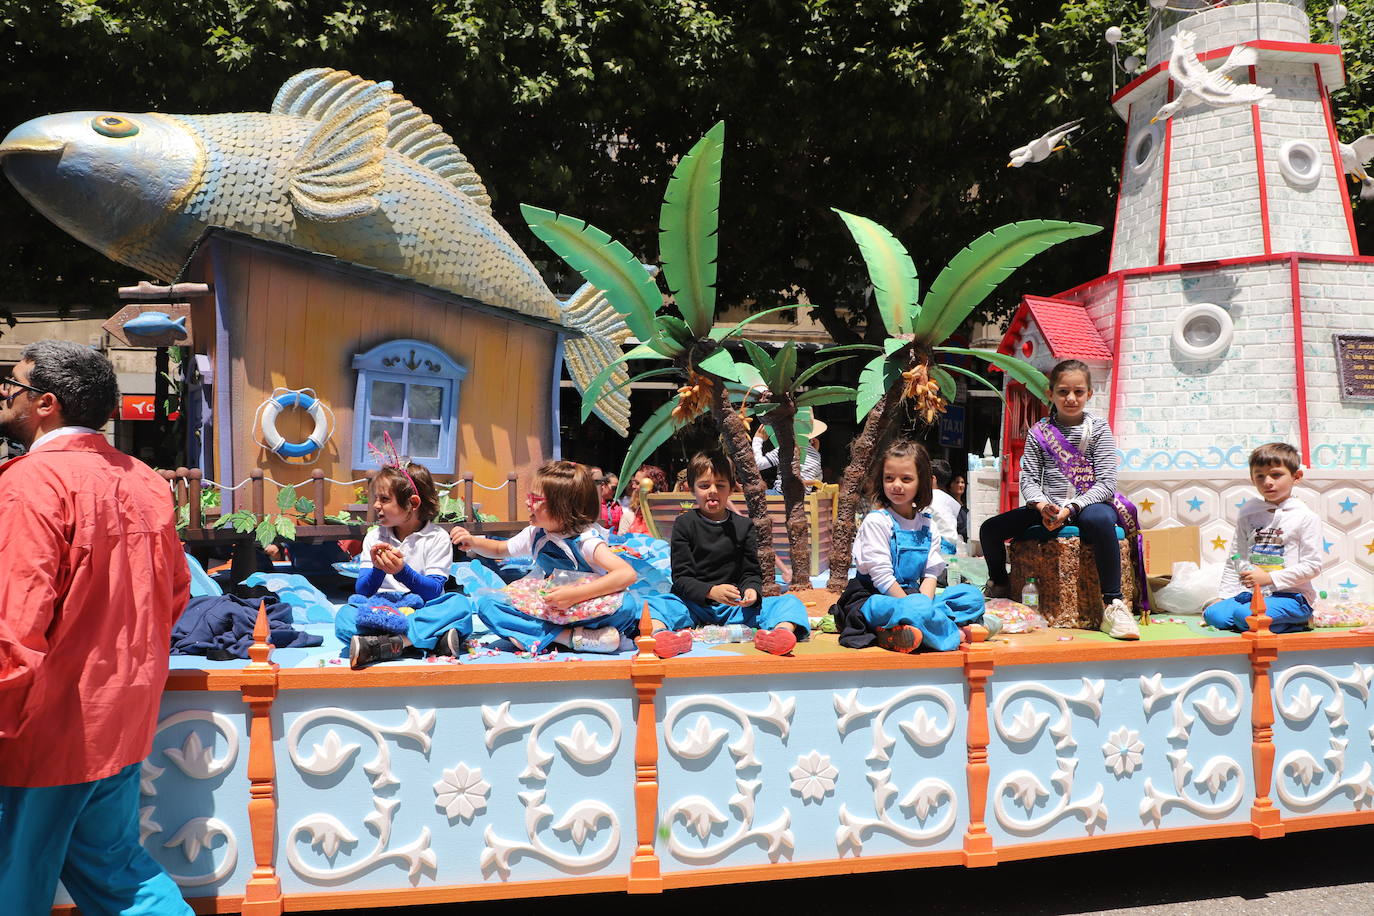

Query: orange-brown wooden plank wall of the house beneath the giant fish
[202,240,556,519]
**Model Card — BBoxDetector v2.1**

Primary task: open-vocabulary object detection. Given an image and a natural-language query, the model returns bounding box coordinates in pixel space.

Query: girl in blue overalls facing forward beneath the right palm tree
[837,441,984,652]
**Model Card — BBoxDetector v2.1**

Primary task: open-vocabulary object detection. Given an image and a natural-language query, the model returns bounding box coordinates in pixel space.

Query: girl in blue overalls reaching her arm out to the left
[449,461,638,652]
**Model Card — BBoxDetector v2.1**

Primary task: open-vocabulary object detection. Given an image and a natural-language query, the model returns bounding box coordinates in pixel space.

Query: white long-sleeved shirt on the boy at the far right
[1219,496,1322,602]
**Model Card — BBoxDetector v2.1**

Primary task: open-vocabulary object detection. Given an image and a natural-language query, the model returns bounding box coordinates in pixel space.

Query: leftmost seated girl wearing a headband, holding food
[334,460,473,667]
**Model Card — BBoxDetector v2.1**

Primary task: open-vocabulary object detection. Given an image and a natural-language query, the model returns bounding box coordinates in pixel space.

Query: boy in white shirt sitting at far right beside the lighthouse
[1202,442,1322,633]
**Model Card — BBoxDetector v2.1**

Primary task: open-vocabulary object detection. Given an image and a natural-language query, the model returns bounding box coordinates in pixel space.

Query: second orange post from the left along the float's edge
[625,602,665,894]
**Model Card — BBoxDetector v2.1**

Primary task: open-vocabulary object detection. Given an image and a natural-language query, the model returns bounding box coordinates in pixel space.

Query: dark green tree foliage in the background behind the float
[0,0,1374,324]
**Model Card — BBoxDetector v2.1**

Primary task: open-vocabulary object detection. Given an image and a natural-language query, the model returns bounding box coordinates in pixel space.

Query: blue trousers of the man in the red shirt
[0,764,191,916]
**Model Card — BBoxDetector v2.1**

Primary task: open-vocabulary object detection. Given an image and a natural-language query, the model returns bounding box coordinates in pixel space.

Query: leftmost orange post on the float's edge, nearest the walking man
[242,602,282,916]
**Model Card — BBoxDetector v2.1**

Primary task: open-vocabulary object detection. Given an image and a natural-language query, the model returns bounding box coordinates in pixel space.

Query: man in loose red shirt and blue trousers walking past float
[0,341,191,916]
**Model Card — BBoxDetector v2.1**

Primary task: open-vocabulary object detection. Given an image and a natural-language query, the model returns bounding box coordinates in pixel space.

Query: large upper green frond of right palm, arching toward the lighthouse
[915,220,1102,345]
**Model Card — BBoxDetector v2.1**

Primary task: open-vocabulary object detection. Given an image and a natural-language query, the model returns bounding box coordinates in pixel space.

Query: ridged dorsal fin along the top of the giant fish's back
[272,67,492,213]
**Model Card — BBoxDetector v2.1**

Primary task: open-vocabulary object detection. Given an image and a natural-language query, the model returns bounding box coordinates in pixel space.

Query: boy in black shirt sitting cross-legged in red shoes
[649,452,809,658]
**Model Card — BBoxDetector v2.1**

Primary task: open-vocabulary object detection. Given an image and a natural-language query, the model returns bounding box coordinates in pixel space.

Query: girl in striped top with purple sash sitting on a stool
[978,360,1140,640]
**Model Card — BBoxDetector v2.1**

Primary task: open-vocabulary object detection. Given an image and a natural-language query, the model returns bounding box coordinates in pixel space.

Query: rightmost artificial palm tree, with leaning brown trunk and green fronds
[827,210,1102,592]
